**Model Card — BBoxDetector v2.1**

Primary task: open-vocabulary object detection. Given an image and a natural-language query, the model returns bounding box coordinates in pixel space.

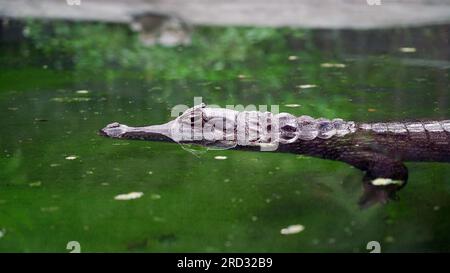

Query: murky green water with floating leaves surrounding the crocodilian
[0,22,450,252]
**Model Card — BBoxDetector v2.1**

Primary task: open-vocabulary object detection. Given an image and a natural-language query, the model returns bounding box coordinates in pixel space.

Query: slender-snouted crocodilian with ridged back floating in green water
[100,104,450,207]
